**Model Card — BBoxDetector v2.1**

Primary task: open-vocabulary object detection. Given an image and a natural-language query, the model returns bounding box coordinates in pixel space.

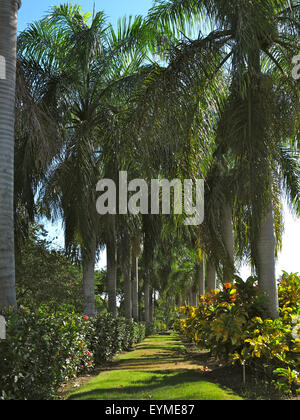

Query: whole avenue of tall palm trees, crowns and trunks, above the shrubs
[0,0,300,322]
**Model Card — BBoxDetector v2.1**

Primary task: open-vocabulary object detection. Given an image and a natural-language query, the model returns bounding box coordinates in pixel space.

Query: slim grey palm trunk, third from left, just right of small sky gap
[107,216,118,318]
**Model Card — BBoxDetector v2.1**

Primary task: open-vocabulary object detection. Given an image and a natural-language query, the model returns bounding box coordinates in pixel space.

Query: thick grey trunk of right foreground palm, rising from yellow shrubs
[257,203,279,319]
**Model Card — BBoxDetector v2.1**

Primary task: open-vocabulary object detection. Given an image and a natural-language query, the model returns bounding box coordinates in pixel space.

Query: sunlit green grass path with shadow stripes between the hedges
[69,334,241,401]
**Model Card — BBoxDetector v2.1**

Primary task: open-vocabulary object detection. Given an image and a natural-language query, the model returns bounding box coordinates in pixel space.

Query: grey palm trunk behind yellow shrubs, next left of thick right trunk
[222,204,234,283]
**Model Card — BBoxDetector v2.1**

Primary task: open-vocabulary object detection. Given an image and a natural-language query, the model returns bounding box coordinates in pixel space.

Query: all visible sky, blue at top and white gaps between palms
[19,0,300,278]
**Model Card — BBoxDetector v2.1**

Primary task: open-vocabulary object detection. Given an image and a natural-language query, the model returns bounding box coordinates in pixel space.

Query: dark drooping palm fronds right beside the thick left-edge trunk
[14,52,62,256]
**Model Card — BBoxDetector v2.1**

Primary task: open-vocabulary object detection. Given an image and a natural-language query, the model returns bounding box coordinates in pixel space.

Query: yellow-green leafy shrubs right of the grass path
[175,273,300,392]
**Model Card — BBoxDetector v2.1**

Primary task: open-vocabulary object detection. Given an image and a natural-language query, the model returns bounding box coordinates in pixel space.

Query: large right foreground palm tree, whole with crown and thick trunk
[144,0,300,318]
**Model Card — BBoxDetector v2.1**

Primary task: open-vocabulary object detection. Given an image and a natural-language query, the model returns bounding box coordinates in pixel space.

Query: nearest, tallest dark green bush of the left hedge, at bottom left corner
[0,309,93,400]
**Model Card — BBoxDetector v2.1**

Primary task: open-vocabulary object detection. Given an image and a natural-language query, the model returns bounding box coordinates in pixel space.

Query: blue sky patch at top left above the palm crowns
[19,0,153,31]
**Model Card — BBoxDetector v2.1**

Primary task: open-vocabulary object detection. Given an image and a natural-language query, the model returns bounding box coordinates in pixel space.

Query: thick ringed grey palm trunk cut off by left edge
[0,0,21,309]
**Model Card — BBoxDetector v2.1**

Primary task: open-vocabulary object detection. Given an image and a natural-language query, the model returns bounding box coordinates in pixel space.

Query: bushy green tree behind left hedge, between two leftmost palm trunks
[16,225,83,312]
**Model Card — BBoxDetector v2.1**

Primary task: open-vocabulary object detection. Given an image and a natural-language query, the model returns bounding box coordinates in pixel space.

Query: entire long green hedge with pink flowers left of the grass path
[0,309,145,400]
